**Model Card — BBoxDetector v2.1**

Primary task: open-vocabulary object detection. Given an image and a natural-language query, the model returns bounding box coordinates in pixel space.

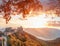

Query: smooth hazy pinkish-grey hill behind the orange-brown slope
[24,28,60,40]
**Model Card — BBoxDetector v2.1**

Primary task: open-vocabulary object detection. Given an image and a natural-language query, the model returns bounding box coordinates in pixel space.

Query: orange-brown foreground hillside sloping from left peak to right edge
[0,27,60,46]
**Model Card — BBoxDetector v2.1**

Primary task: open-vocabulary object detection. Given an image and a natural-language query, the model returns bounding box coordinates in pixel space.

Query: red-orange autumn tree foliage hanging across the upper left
[0,0,42,23]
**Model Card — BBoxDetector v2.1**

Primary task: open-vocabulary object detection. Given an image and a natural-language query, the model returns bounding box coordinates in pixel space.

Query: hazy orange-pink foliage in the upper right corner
[46,0,60,17]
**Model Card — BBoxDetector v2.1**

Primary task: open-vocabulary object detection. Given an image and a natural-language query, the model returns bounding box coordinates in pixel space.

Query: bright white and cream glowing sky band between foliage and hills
[0,11,60,28]
